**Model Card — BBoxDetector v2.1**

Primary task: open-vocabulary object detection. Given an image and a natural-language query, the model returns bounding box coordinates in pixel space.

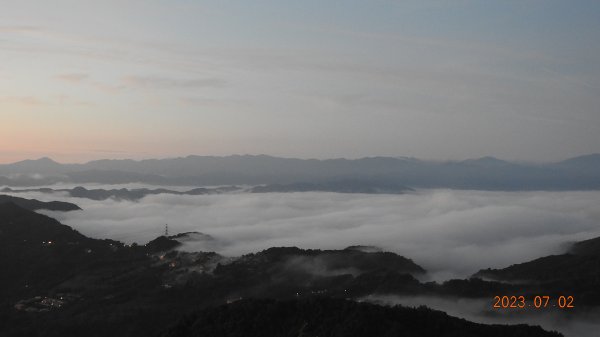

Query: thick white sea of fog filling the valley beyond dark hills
[15,190,600,280]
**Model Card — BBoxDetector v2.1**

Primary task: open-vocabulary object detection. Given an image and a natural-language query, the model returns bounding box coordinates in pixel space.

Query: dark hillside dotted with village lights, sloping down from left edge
[0,203,598,337]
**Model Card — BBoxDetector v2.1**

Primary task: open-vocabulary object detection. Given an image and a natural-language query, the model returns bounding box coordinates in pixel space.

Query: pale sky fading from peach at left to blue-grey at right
[0,0,600,162]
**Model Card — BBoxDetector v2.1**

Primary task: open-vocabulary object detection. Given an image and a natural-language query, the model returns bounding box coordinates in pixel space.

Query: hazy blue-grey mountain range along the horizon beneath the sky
[0,154,600,191]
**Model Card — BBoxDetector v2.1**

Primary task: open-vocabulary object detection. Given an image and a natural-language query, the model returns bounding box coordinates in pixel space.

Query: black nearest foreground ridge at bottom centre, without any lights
[162,297,561,337]
